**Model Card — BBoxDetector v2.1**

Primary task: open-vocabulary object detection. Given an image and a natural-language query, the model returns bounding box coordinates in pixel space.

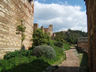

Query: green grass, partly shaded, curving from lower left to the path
[0,44,70,72]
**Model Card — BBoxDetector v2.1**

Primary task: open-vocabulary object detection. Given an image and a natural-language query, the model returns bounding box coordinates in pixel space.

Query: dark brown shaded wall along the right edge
[85,0,96,72]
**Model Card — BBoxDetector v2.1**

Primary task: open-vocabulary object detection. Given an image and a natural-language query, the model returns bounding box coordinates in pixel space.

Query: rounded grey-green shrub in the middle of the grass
[32,45,56,59]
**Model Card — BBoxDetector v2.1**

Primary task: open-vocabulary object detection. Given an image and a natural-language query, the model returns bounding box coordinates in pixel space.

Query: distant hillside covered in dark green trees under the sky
[54,29,88,44]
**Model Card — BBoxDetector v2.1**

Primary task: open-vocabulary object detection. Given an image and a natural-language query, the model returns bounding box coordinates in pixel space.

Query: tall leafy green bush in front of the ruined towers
[33,29,50,46]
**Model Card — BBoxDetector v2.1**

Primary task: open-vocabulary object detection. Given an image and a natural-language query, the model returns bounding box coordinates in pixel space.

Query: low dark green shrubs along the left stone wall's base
[4,50,32,59]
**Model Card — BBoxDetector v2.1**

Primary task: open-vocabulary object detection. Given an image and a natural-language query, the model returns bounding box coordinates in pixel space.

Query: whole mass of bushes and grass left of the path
[0,29,70,72]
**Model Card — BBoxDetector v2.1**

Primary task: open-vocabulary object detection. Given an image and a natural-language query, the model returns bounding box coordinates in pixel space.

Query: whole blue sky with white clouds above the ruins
[34,0,87,32]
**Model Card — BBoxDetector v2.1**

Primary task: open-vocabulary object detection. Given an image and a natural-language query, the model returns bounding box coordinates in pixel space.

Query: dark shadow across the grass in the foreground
[2,59,50,72]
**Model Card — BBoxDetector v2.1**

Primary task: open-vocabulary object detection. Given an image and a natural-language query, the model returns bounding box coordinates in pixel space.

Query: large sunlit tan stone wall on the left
[0,0,34,57]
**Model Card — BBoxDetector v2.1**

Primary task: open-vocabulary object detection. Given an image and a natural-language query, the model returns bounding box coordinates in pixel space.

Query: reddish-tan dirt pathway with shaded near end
[55,48,80,72]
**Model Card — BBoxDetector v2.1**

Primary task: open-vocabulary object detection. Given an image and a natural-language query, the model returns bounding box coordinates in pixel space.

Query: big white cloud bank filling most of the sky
[34,1,87,31]
